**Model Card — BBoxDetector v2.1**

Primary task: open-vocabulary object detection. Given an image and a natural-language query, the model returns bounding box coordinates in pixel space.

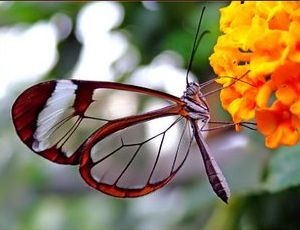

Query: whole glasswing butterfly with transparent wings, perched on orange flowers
[12,9,252,203]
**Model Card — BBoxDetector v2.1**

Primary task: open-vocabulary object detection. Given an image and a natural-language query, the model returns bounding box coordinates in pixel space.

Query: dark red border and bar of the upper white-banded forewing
[12,80,182,165]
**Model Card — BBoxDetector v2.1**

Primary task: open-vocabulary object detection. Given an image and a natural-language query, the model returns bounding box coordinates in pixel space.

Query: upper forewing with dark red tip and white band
[12,80,180,164]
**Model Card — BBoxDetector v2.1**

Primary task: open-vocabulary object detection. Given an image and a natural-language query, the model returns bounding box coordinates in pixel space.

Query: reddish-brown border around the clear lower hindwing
[80,105,189,197]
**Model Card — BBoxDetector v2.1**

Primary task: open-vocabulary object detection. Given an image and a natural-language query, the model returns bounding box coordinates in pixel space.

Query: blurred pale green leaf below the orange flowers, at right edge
[264,146,300,192]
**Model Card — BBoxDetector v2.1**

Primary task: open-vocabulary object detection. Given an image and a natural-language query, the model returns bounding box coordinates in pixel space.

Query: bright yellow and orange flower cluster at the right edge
[210,1,300,148]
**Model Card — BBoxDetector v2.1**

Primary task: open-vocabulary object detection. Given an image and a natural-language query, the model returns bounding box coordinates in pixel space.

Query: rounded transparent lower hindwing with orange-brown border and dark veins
[80,115,193,197]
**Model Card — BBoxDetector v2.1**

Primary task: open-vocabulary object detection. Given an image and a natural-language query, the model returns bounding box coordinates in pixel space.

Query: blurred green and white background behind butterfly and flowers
[0,2,300,230]
